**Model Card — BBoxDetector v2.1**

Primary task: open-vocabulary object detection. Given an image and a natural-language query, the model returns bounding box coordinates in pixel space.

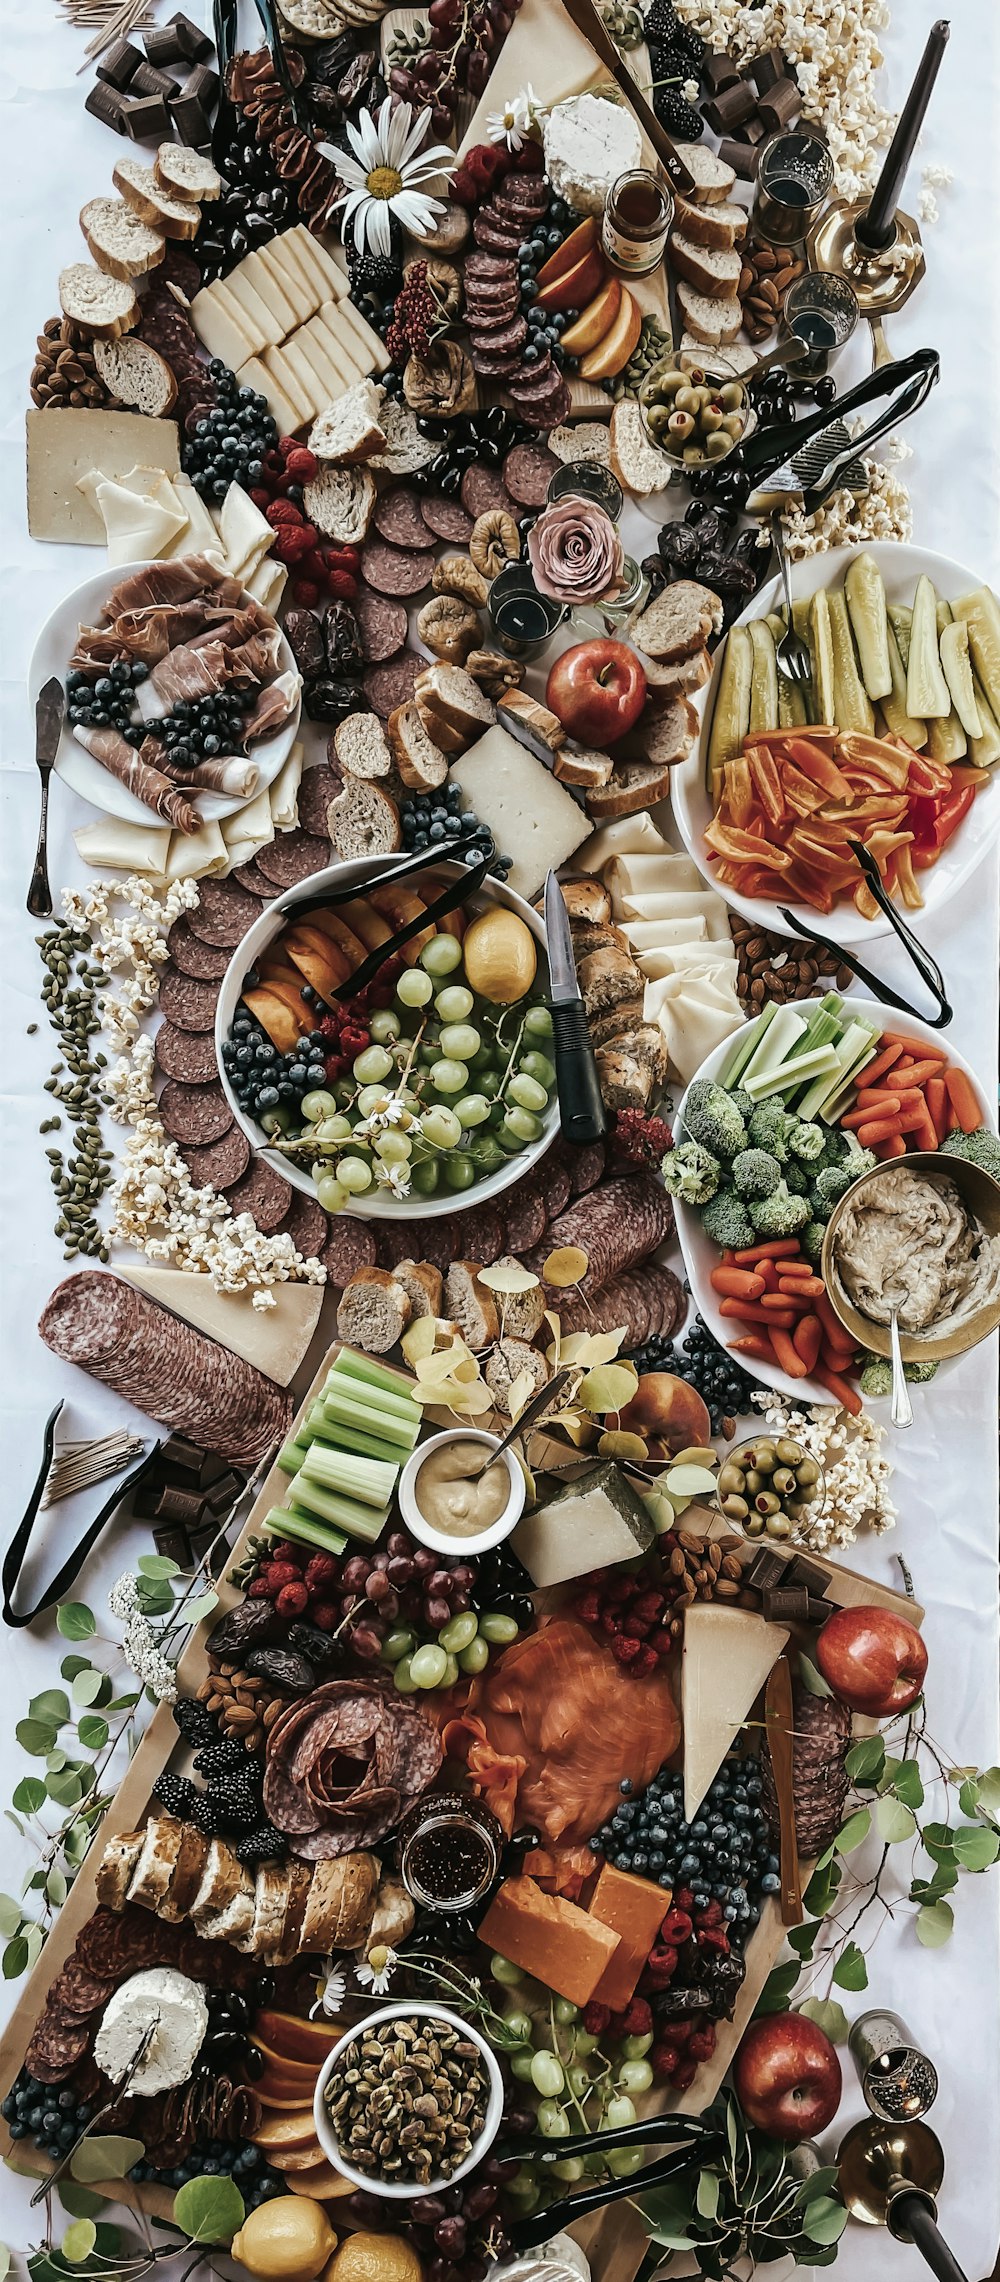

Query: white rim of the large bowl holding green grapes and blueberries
[215,856,559,1221]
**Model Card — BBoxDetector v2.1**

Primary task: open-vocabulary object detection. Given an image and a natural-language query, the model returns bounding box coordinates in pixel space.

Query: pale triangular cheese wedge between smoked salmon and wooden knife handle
[680,1602,788,1821]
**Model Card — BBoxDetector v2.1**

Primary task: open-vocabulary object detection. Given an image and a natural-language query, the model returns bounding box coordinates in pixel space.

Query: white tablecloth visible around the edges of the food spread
[0,0,1000,2282]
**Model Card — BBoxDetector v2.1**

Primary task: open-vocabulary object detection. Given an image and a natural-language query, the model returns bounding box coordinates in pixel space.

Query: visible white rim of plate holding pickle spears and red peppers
[671,541,1000,942]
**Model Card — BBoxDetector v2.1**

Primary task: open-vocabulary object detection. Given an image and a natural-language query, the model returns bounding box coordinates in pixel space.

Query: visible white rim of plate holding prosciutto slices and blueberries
[27,564,301,824]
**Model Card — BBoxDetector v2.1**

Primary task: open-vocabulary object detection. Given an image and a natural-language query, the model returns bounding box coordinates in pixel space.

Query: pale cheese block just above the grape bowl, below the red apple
[452,726,591,899]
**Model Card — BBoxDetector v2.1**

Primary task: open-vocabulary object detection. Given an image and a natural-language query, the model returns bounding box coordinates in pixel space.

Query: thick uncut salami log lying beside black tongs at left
[39,1269,295,1469]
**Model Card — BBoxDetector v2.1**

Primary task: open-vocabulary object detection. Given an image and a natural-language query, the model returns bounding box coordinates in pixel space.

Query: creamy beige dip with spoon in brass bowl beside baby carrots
[833,1164,1000,1337]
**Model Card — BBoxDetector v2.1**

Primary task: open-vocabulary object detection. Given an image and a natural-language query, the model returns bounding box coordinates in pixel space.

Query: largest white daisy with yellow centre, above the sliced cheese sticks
[320,96,454,253]
